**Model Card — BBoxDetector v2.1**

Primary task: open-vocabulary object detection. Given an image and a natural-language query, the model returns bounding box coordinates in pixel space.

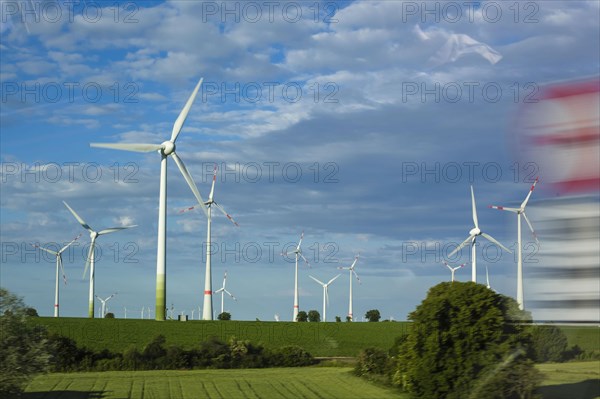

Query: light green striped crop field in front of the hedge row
[23,367,405,399]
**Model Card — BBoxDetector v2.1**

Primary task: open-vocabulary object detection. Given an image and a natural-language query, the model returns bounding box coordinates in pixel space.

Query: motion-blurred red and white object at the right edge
[515,77,600,323]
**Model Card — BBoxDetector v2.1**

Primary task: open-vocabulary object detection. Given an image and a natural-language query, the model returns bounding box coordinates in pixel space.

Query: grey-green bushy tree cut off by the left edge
[0,288,50,398]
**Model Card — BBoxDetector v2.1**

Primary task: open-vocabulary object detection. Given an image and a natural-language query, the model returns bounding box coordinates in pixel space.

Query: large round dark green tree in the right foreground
[393,282,532,399]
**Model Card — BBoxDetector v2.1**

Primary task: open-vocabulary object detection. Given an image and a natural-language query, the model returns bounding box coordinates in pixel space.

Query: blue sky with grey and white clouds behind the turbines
[0,0,600,320]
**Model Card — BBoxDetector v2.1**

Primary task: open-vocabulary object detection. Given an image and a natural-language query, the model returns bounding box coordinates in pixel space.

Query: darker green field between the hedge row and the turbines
[31,317,409,356]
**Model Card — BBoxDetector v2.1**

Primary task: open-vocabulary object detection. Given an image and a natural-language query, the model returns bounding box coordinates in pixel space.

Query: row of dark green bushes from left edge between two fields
[0,288,315,398]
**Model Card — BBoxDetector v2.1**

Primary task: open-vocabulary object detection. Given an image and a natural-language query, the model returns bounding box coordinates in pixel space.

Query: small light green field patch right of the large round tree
[536,361,600,399]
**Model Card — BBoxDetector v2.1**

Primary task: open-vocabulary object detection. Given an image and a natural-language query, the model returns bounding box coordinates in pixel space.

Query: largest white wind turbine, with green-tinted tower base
[90,79,208,320]
